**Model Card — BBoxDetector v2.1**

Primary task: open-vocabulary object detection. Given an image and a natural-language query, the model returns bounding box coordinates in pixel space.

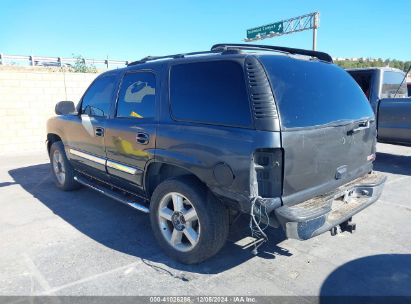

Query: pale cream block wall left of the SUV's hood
[0,67,98,155]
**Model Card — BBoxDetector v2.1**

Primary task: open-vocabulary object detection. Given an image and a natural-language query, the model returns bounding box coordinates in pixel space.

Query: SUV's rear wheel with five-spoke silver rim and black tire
[150,177,229,264]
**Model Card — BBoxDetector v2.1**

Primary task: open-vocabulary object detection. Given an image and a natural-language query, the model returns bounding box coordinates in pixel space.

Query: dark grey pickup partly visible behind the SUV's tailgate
[347,68,411,144]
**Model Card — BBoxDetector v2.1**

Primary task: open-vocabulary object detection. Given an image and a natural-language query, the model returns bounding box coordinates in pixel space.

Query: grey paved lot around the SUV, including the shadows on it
[0,144,411,296]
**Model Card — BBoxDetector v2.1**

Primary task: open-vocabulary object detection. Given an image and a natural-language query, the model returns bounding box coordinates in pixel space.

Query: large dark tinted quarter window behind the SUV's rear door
[170,61,252,127]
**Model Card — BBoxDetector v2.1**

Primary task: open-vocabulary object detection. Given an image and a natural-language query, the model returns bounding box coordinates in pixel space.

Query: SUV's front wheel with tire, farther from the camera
[50,141,80,191]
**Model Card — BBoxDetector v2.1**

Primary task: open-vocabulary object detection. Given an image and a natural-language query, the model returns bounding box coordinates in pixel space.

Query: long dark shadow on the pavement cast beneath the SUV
[9,164,291,274]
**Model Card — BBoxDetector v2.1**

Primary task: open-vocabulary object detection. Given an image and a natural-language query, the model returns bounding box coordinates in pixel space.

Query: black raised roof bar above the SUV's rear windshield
[211,43,333,63]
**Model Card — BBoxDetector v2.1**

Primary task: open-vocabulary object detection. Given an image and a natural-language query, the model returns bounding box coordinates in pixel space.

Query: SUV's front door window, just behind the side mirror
[81,75,116,117]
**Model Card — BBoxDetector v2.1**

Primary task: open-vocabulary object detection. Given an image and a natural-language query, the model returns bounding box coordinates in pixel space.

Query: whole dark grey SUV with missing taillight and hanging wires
[47,44,385,263]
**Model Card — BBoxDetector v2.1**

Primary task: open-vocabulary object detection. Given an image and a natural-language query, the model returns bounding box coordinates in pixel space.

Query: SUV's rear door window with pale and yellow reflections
[117,72,156,119]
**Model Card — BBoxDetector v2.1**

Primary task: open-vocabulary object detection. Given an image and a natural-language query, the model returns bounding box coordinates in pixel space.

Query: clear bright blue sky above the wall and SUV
[0,0,411,60]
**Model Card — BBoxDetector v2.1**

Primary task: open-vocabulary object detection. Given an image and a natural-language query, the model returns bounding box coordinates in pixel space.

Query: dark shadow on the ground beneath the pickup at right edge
[374,152,411,175]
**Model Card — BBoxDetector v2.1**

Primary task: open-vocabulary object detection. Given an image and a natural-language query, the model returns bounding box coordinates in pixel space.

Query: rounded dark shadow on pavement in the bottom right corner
[320,254,411,303]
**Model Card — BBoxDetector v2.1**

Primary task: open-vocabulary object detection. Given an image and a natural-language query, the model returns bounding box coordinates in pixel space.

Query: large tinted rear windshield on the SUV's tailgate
[260,56,374,128]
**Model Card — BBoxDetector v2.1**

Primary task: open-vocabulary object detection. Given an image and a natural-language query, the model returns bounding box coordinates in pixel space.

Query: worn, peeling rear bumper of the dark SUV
[275,172,386,240]
